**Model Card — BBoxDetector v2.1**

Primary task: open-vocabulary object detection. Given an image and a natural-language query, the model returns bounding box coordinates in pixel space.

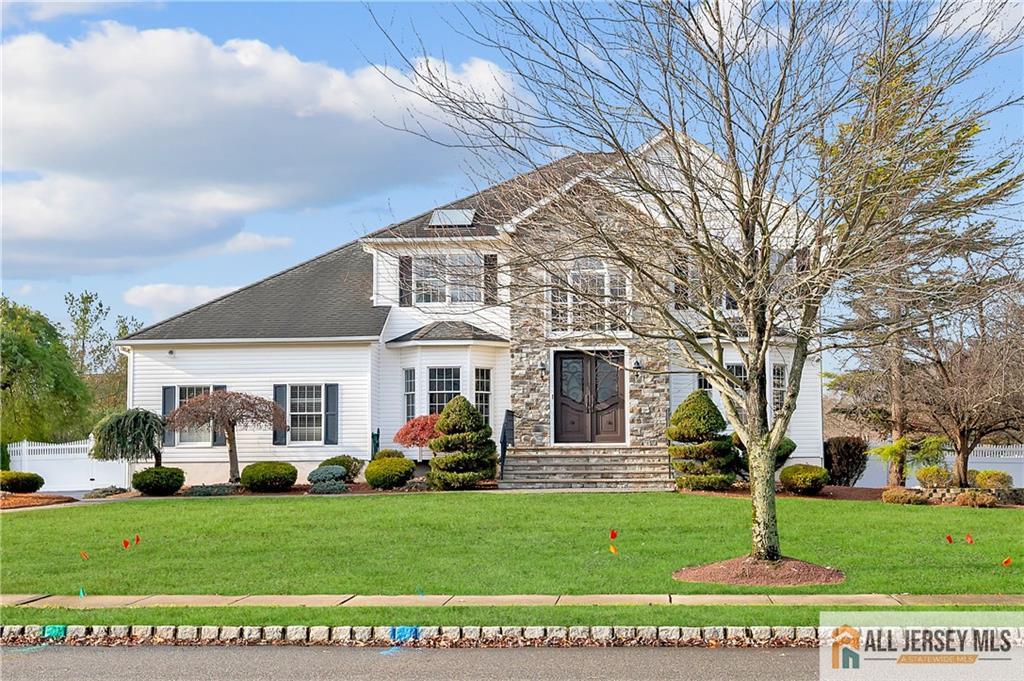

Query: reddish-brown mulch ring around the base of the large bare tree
[672,556,846,587]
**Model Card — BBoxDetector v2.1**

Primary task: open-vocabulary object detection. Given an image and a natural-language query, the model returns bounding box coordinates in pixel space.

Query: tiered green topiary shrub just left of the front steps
[427,395,498,490]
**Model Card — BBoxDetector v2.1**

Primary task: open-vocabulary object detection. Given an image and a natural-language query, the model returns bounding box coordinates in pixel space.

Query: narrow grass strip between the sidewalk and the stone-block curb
[0,605,1015,627]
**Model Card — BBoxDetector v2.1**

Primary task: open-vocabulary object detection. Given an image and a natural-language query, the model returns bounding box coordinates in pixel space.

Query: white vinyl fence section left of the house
[7,437,129,492]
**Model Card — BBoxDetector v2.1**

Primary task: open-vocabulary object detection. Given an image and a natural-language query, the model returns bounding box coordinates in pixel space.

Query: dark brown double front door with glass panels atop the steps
[554,350,626,442]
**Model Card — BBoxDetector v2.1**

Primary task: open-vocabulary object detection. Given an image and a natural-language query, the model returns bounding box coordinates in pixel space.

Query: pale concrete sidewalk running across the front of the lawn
[0,594,1024,609]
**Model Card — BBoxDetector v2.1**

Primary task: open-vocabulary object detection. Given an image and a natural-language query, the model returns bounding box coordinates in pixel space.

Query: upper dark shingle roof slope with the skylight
[367,153,613,239]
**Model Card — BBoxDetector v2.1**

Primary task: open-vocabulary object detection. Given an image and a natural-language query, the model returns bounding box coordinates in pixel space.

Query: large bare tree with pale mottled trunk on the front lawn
[378,0,1021,560]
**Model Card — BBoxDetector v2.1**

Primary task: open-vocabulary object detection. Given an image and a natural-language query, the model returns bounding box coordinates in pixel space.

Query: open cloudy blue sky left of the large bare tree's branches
[2,2,1024,337]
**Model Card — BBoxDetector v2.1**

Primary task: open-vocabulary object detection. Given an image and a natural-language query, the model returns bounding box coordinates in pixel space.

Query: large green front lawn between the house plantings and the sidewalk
[0,493,1024,593]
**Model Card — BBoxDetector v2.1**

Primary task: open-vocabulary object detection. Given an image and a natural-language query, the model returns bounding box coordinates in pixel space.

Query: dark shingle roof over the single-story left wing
[125,242,390,344]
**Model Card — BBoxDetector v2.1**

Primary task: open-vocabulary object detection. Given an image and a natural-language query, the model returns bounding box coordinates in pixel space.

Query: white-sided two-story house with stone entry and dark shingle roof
[121,151,821,488]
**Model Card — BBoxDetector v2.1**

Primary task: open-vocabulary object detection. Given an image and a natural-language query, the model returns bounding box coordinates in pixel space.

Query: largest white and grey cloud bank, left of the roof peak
[2,22,508,278]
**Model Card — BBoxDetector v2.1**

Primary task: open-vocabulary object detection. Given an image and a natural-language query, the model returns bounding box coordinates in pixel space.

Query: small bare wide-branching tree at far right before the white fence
[907,297,1024,487]
